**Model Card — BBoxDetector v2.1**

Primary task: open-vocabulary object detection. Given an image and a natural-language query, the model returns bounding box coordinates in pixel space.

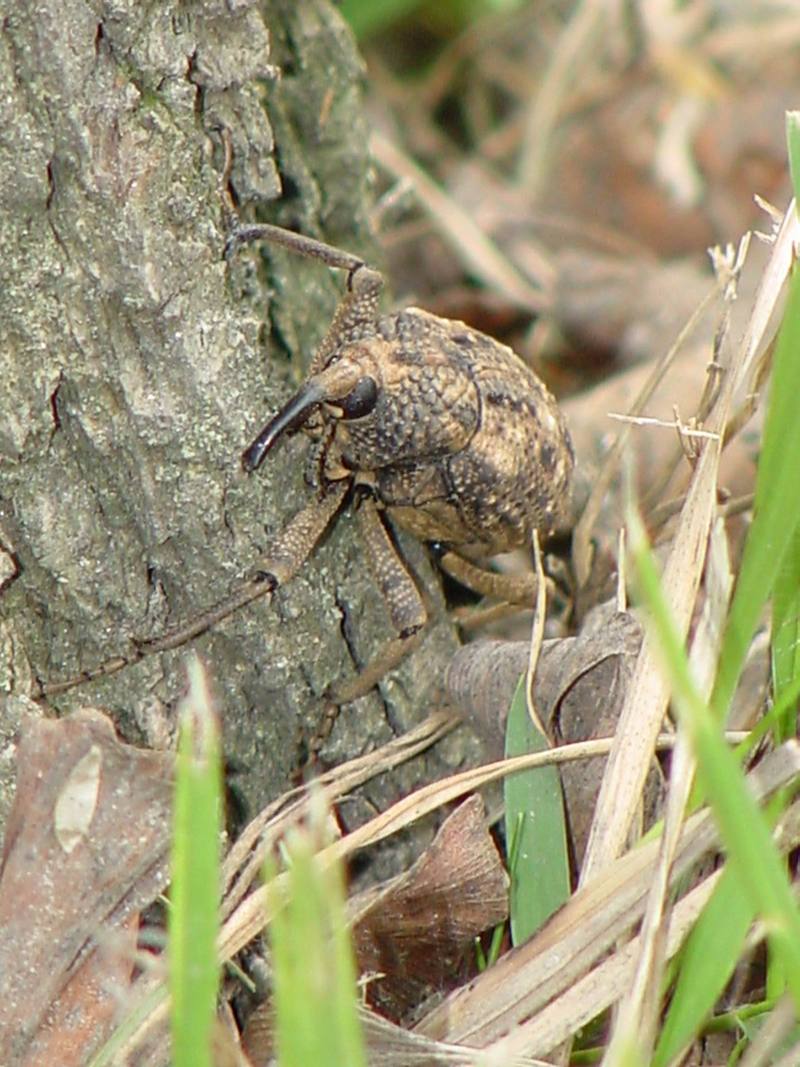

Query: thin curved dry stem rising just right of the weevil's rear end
[573,284,720,586]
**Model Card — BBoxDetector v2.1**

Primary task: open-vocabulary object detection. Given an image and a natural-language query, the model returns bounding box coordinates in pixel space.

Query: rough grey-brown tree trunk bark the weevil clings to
[0,0,469,823]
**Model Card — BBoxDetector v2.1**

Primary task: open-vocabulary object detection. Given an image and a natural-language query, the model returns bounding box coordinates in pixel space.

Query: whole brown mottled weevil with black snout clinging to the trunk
[34,224,574,702]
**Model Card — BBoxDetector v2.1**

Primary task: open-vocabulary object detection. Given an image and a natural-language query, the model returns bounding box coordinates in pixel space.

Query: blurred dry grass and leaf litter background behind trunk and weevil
[330,0,800,395]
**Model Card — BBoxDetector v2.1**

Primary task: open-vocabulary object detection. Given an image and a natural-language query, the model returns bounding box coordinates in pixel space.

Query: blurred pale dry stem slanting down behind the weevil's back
[370,132,554,312]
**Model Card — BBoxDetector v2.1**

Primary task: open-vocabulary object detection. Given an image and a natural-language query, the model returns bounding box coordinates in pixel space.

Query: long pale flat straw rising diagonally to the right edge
[581,212,798,883]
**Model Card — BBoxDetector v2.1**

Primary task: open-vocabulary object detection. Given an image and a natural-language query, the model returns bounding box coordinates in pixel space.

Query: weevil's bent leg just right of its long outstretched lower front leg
[331,497,428,704]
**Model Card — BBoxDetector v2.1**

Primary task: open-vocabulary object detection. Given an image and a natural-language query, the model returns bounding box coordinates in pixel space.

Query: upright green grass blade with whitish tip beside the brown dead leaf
[169,658,222,1067]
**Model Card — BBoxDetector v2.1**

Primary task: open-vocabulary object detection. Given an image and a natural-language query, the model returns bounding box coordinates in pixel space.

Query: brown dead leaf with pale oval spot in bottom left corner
[0,708,172,1067]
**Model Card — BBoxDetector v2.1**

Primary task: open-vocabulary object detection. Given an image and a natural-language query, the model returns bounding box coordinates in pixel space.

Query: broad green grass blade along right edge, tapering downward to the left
[711,261,800,720]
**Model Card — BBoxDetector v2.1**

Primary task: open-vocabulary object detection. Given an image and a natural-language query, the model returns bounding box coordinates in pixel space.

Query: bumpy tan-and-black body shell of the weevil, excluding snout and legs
[323,308,574,556]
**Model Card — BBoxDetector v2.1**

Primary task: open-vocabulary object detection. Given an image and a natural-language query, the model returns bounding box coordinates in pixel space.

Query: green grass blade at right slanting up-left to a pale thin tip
[630,514,800,1012]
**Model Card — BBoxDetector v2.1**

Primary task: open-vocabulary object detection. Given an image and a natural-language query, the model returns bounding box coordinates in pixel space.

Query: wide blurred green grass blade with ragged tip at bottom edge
[267,802,367,1067]
